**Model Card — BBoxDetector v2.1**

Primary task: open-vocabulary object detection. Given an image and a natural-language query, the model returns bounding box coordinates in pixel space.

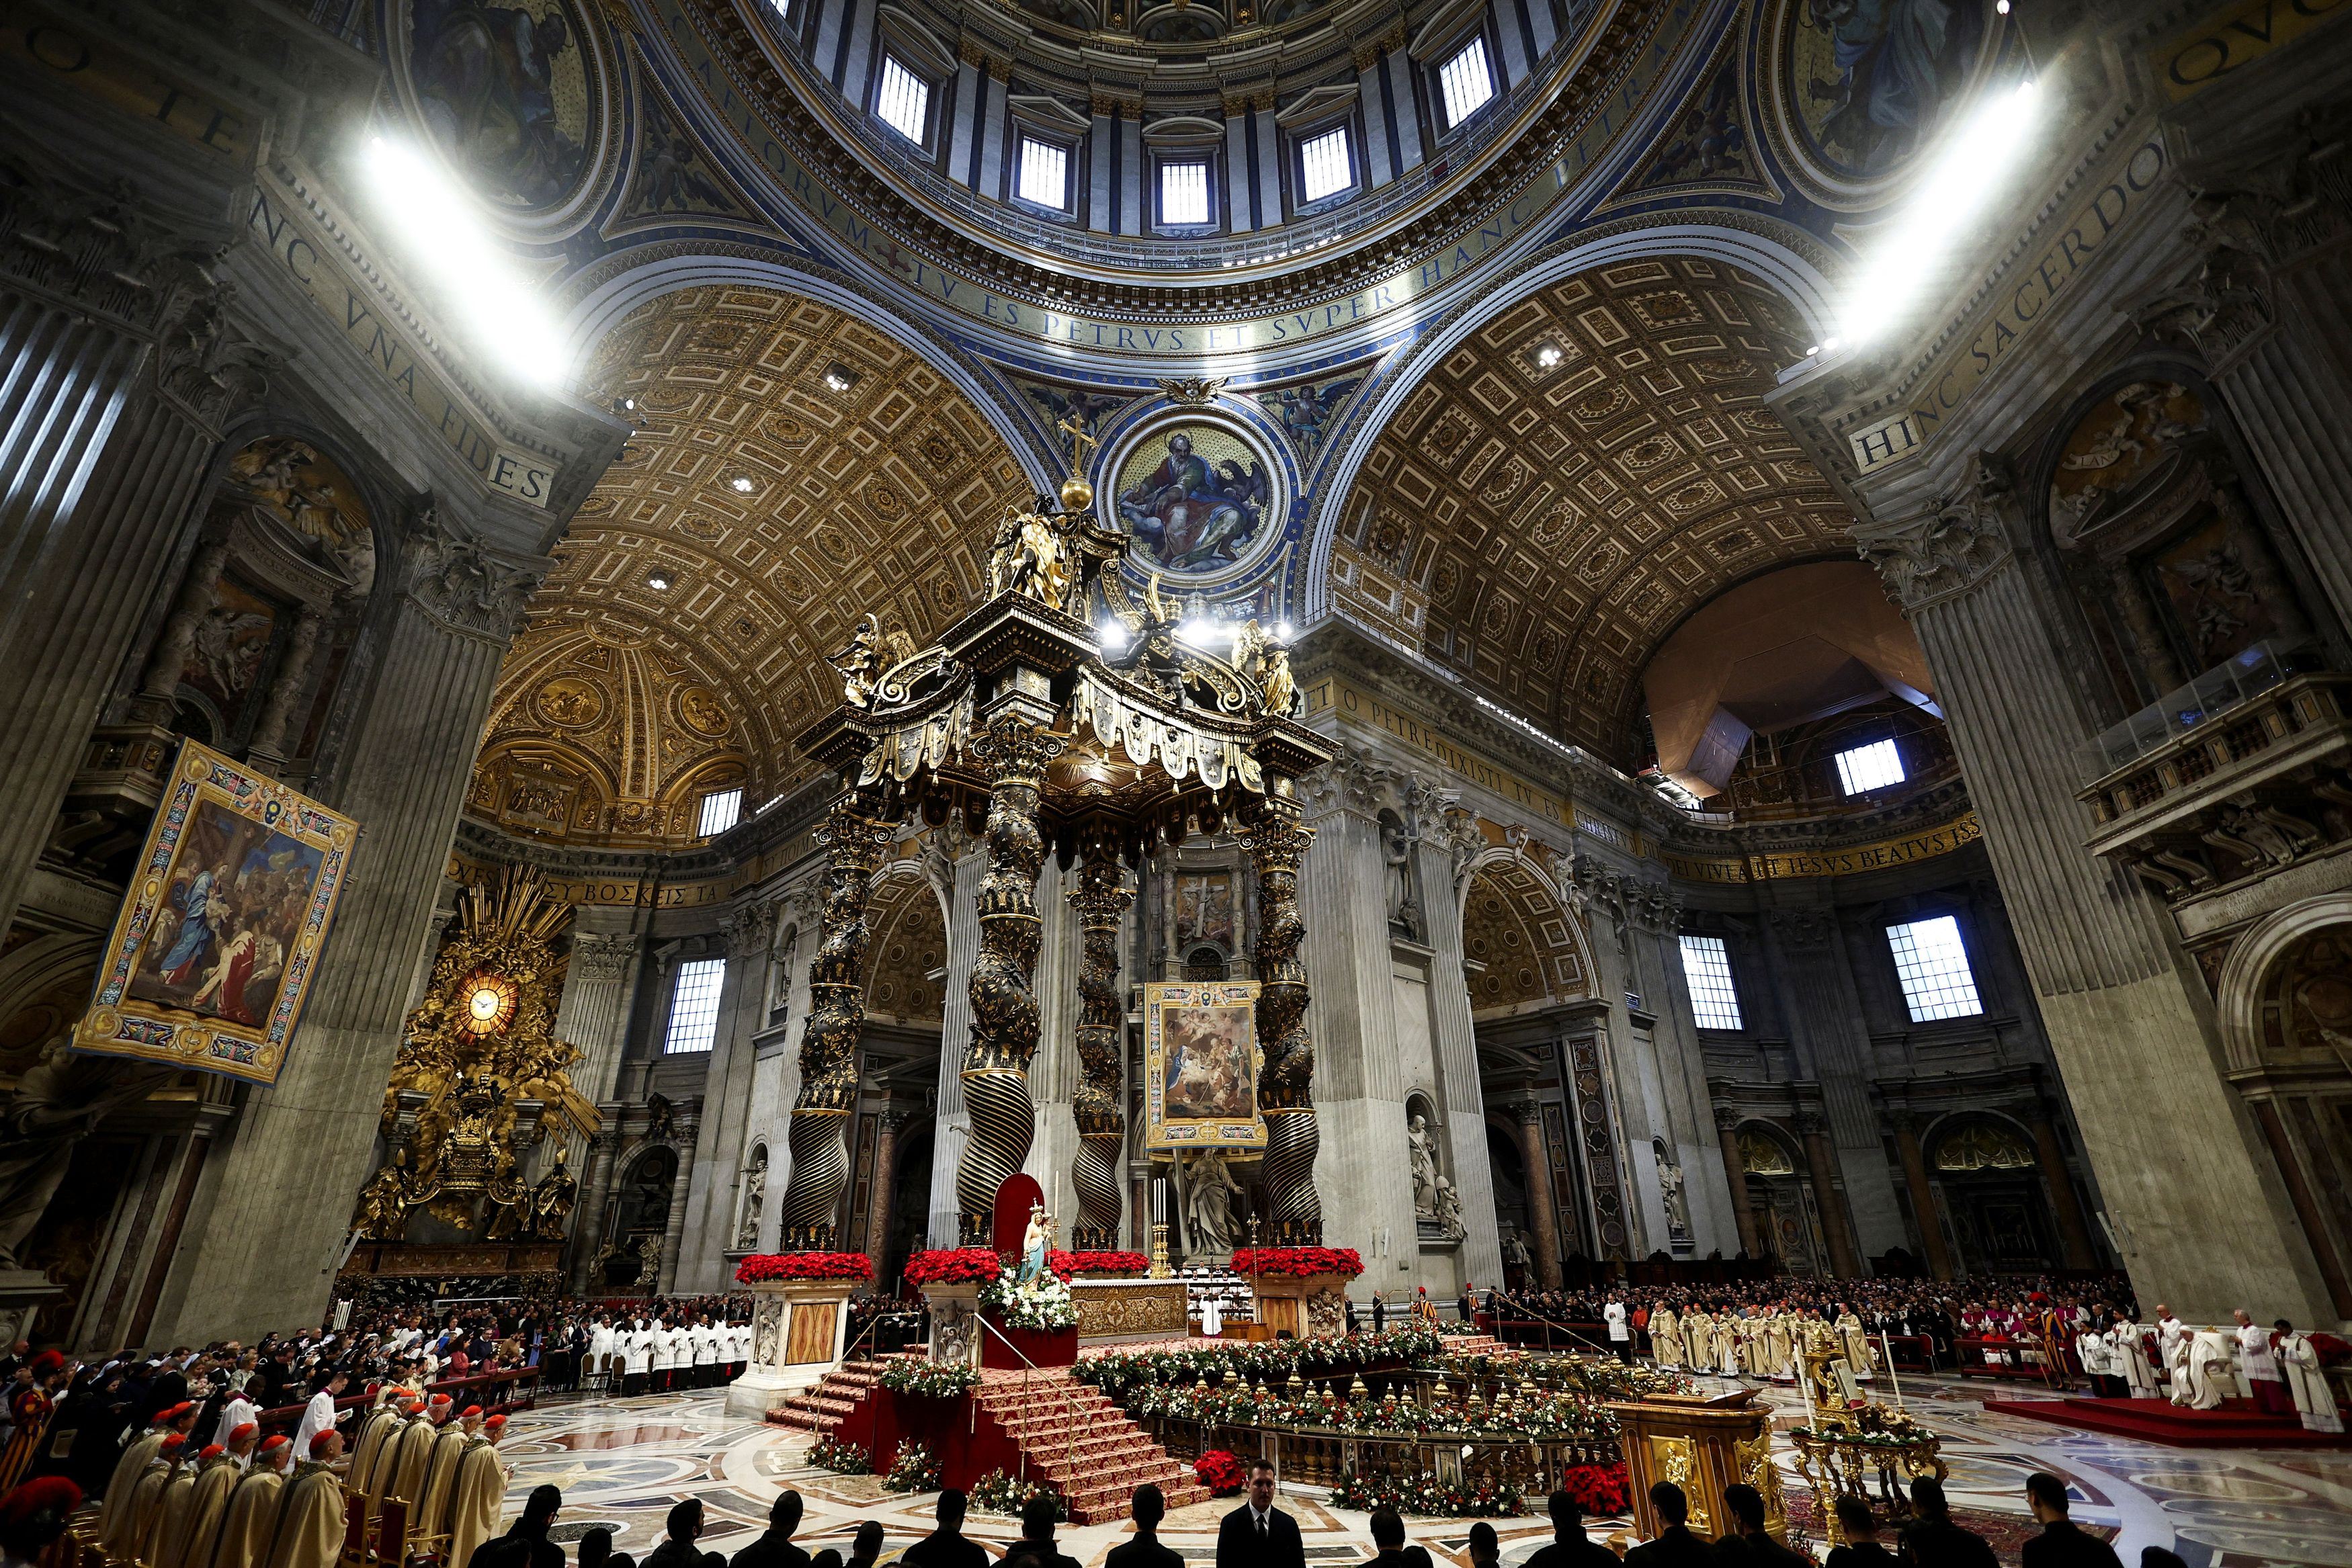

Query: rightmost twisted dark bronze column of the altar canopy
[1240,778,1322,1246]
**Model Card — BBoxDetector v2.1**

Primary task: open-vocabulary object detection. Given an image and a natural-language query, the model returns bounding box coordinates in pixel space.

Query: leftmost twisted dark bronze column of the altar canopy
[779,795,892,1253]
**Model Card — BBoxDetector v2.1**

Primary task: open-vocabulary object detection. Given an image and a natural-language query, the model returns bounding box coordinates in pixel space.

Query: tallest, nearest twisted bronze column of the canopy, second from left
[955,717,1063,1246]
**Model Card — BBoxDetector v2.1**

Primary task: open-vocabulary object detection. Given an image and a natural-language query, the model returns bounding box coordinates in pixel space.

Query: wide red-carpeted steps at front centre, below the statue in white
[976,1368,1209,1524]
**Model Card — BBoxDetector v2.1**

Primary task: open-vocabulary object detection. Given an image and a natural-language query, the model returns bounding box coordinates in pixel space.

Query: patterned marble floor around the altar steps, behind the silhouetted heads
[501,1380,2352,1568]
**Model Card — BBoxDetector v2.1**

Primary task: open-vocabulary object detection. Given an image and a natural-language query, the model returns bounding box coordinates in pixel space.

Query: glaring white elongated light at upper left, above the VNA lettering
[367,136,567,386]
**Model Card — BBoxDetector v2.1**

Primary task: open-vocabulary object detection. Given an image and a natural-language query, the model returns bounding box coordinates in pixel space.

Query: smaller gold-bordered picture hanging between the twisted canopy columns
[1143,980,1265,1152]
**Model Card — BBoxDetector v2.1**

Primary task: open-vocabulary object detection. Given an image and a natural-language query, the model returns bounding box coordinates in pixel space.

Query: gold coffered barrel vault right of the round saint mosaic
[1331,259,1853,762]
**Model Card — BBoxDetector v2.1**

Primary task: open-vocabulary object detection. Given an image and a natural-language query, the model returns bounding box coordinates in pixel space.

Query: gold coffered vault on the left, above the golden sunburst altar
[470,287,1028,842]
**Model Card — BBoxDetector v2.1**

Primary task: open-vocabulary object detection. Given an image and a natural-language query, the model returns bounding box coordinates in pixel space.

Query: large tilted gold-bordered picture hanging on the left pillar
[71,740,360,1084]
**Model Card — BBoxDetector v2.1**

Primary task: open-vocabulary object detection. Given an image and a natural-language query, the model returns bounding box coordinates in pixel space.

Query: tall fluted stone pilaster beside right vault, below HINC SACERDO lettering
[1863,482,2331,1321]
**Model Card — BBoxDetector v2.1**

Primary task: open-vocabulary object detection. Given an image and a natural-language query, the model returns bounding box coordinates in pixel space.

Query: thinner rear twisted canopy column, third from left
[1068,842,1136,1251]
